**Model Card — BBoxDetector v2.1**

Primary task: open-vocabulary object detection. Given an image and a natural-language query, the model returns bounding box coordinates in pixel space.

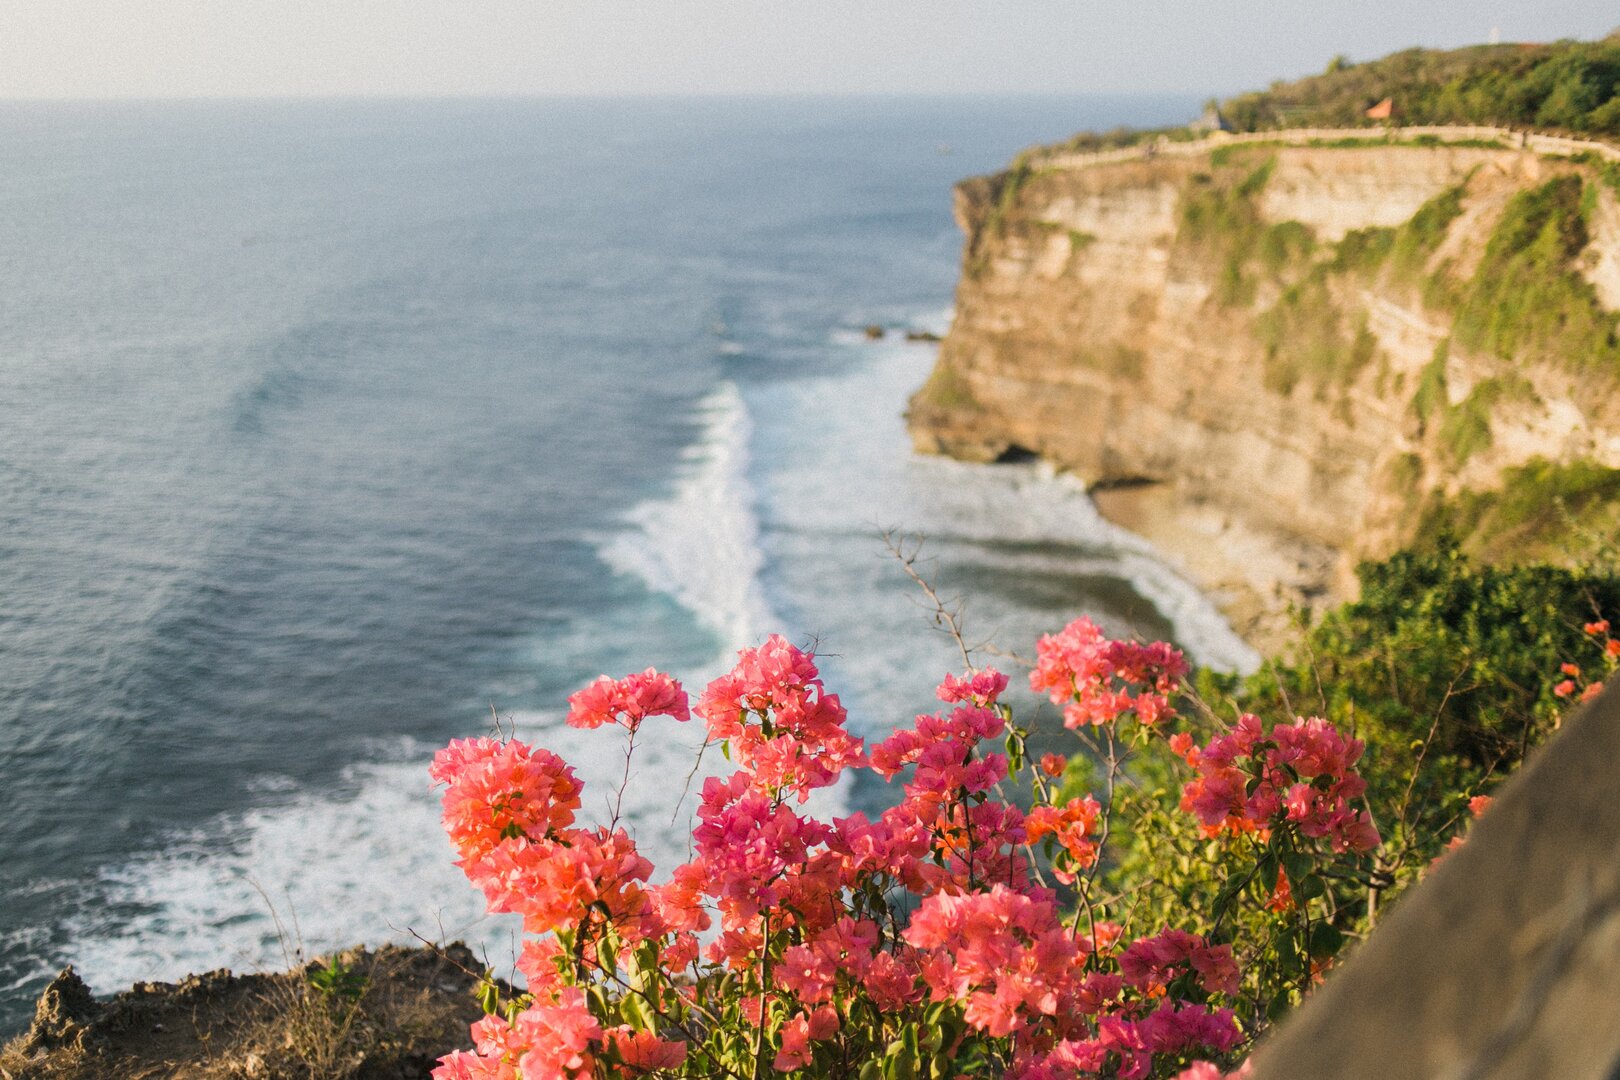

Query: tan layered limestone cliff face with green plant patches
[909,134,1620,643]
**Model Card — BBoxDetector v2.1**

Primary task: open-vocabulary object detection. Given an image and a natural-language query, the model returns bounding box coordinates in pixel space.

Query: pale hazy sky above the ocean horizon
[0,0,1620,97]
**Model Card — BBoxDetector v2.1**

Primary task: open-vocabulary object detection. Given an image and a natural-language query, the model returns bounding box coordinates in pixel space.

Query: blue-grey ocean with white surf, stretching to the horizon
[0,97,1254,1031]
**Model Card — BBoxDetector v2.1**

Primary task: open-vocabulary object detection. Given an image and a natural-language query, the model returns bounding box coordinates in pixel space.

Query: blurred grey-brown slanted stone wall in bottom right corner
[1254,687,1620,1080]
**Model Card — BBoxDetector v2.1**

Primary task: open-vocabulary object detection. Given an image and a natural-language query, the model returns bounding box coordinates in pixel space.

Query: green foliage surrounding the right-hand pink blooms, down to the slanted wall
[1066,538,1620,977]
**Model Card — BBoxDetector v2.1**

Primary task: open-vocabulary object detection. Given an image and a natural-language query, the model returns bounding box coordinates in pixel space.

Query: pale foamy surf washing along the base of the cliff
[753,321,1259,670]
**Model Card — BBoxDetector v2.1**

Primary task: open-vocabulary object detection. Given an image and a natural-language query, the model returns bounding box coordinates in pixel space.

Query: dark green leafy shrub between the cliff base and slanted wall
[1200,534,1620,905]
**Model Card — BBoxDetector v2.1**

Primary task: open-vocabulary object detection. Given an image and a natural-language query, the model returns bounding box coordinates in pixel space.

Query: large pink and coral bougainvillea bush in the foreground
[433,619,1379,1080]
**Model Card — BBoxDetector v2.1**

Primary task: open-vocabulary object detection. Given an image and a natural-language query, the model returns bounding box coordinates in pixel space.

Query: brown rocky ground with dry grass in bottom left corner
[0,944,483,1080]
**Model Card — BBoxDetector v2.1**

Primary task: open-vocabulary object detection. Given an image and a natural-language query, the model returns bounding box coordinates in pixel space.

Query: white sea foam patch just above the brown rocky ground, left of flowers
[65,743,517,991]
